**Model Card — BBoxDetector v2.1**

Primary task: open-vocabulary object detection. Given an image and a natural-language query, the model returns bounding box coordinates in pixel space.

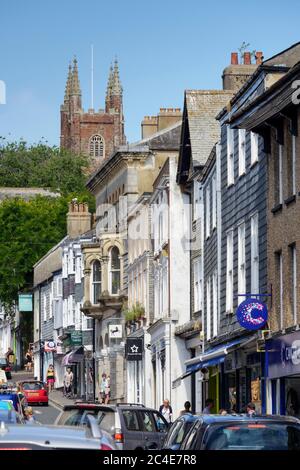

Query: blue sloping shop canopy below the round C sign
[180,336,254,379]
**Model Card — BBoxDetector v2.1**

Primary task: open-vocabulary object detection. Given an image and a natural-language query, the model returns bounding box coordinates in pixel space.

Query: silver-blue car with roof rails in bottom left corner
[0,417,115,450]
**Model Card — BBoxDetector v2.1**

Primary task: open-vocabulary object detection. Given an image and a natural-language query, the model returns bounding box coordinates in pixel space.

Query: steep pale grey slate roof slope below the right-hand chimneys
[185,90,233,165]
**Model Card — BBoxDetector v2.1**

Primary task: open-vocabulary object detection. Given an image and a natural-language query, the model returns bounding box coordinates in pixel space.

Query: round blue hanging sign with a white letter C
[236,298,268,330]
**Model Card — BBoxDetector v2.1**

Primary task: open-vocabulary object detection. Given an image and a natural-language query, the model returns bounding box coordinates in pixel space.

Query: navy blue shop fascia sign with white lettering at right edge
[266,331,300,378]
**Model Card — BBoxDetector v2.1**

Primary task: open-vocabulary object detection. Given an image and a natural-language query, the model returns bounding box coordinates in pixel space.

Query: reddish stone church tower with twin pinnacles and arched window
[60,59,126,163]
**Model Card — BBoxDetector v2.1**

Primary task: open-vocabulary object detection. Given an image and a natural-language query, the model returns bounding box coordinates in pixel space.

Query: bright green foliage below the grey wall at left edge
[0,196,68,305]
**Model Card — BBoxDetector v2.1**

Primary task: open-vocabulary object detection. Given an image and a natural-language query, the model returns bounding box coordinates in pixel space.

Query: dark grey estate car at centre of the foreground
[56,403,169,450]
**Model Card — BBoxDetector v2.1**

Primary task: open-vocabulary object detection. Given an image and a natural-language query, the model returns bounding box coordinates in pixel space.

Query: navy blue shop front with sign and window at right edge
[266,331,300,418]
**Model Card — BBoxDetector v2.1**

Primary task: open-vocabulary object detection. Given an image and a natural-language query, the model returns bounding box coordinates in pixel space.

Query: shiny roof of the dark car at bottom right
[197,413,300,424]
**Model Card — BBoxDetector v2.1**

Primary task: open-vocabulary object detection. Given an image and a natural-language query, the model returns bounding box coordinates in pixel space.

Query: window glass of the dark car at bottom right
[204,422,300,450]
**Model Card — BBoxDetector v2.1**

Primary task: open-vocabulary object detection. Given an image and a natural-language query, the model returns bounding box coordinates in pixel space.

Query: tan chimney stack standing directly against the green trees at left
[67,199,92,238]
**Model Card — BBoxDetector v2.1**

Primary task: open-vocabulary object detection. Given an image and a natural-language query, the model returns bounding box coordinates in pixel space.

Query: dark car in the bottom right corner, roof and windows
[180,415,300,450]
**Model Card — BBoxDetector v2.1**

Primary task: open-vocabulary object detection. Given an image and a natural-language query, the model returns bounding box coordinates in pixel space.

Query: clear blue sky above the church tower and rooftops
[0,0,300,145]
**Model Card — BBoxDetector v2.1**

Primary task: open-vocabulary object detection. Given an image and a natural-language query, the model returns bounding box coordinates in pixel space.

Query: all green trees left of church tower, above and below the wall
[0,137,95,309]
